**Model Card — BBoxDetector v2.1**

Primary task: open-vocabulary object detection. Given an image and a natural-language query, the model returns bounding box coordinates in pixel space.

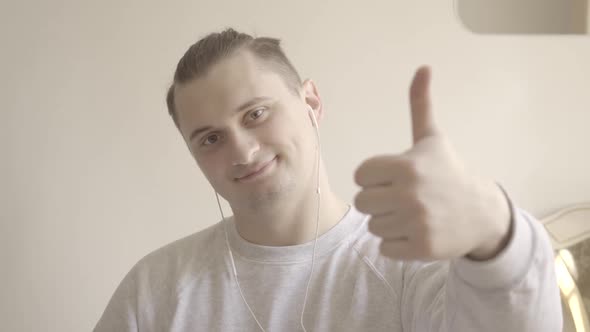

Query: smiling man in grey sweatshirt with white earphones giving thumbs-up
[95,29,562,332]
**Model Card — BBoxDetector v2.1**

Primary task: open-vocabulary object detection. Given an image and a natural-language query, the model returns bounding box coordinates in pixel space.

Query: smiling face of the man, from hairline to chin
[175,52,316,210]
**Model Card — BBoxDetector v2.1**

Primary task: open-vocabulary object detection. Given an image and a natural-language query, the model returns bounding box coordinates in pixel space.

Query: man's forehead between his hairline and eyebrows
[174,52,296,130]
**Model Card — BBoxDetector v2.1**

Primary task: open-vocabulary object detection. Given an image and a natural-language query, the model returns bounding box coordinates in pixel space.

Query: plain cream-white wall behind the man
[0,0,590,332]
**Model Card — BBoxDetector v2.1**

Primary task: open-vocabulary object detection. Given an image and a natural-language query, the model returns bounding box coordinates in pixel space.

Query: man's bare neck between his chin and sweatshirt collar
[234,161,348,246]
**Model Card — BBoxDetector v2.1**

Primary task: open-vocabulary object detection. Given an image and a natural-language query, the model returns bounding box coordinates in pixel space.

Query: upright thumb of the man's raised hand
[410,66,437,144]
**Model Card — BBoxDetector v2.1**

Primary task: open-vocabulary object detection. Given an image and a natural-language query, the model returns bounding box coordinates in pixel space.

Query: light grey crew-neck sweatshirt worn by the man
[94,206,562,332]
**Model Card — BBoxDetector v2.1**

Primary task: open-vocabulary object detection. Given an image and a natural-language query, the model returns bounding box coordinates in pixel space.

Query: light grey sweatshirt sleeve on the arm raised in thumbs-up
[401,201,563,332]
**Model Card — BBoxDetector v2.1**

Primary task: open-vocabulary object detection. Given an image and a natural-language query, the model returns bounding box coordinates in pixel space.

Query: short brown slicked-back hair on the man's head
[166,28,301,128]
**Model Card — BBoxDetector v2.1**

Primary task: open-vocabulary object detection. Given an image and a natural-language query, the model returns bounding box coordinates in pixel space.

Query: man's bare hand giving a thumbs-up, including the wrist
[354,67,511,260]
